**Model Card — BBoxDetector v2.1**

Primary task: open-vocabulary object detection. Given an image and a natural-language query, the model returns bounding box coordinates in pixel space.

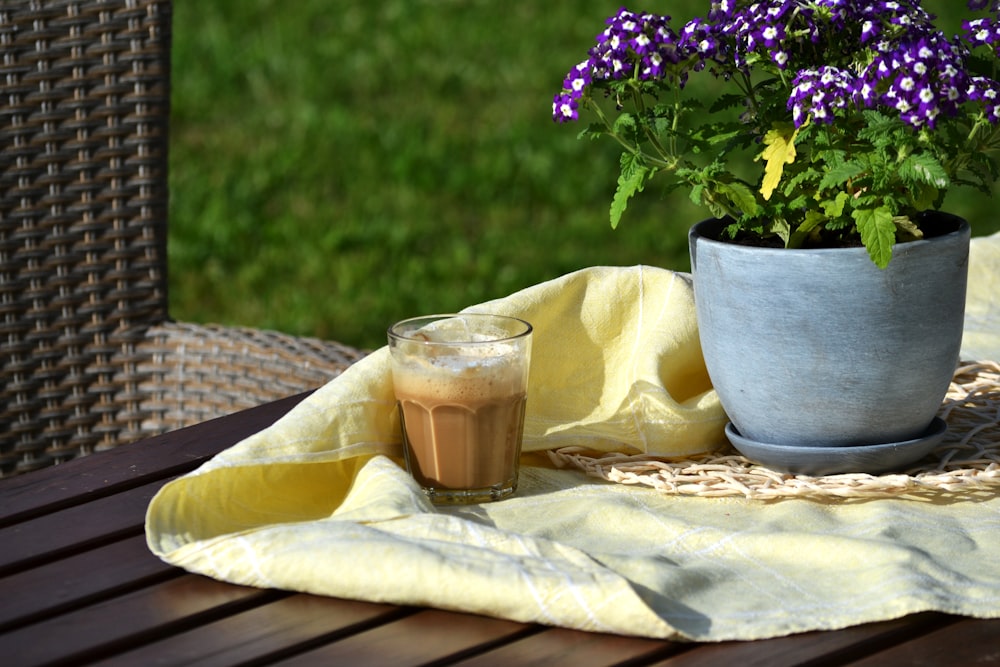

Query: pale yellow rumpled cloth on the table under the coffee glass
[146,267,1000,640]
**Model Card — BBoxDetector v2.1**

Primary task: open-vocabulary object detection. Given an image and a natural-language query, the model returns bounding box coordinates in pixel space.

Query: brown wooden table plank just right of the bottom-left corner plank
[87,595,414,667]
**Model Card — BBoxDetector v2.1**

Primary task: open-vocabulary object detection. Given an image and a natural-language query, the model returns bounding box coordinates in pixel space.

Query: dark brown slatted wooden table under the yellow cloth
[0,396,1000,667]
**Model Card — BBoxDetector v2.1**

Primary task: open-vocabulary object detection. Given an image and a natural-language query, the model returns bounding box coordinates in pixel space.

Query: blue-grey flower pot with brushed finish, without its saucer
[689,214,970,446]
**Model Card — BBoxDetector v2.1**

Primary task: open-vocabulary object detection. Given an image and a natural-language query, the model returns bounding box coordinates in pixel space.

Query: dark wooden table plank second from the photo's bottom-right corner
[655,613,955,667]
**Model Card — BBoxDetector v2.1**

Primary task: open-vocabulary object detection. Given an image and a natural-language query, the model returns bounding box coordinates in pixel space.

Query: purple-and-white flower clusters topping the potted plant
[553,0,1000,128]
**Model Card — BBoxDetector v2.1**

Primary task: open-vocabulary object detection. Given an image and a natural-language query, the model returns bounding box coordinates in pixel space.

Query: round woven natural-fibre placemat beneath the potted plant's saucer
[549,361,1000,499]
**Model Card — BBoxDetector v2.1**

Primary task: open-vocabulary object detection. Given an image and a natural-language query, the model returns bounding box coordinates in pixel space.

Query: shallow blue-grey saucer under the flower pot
[726,417,948,477]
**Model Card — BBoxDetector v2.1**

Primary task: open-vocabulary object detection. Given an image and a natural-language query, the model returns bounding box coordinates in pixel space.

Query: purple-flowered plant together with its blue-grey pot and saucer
[553,0,1000,472]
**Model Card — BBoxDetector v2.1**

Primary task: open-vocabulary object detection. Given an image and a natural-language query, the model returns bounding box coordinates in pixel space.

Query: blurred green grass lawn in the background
[169,0,1000,347]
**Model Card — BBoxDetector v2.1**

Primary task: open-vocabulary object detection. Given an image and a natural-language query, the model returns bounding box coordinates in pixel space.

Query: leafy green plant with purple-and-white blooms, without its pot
[558,0,1000,268]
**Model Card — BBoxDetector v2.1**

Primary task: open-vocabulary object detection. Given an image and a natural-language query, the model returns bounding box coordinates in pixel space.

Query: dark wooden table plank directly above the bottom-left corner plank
[0,535,177,632]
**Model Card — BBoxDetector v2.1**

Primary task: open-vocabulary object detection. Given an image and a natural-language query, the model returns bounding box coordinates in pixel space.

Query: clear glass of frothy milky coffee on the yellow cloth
[388,313,532,504]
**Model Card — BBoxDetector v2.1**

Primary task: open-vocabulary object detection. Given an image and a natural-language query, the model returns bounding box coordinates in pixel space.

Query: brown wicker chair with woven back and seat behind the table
[0,0,363,476]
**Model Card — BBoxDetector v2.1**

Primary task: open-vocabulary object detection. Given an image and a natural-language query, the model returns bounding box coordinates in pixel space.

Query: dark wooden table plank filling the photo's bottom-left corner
[0,575,287,667]
